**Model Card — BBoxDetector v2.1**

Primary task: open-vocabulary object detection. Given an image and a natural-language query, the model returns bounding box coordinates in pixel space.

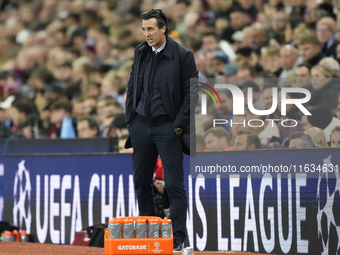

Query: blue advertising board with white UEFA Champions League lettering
[4,149,340,254]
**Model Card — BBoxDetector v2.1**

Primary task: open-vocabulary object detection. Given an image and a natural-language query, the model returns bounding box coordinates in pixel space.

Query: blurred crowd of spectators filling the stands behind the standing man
[0,0,340,152]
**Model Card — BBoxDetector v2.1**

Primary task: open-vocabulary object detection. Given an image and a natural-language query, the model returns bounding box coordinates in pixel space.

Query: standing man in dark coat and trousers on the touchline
[125,9,198,250]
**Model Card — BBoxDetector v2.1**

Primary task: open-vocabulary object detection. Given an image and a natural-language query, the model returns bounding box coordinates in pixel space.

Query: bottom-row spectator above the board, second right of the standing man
[233,130,260,151]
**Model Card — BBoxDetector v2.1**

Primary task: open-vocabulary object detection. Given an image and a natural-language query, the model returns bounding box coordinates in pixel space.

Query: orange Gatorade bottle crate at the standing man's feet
[104,216,173,255]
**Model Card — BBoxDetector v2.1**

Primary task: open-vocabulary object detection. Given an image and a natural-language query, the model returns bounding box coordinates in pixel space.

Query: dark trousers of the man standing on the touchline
[129,118,188,242]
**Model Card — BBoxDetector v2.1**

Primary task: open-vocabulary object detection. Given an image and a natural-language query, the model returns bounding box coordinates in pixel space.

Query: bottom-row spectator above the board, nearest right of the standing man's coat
[204,127,233,151]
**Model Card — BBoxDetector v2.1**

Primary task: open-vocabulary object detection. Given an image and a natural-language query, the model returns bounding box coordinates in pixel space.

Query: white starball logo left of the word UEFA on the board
[13,160,32,233]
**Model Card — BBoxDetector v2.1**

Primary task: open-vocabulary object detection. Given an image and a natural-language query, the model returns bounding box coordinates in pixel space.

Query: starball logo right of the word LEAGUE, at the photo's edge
[316,156,340,255]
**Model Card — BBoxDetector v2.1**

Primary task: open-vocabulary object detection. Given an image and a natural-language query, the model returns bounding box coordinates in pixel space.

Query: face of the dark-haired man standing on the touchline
[142,18,166,49]
